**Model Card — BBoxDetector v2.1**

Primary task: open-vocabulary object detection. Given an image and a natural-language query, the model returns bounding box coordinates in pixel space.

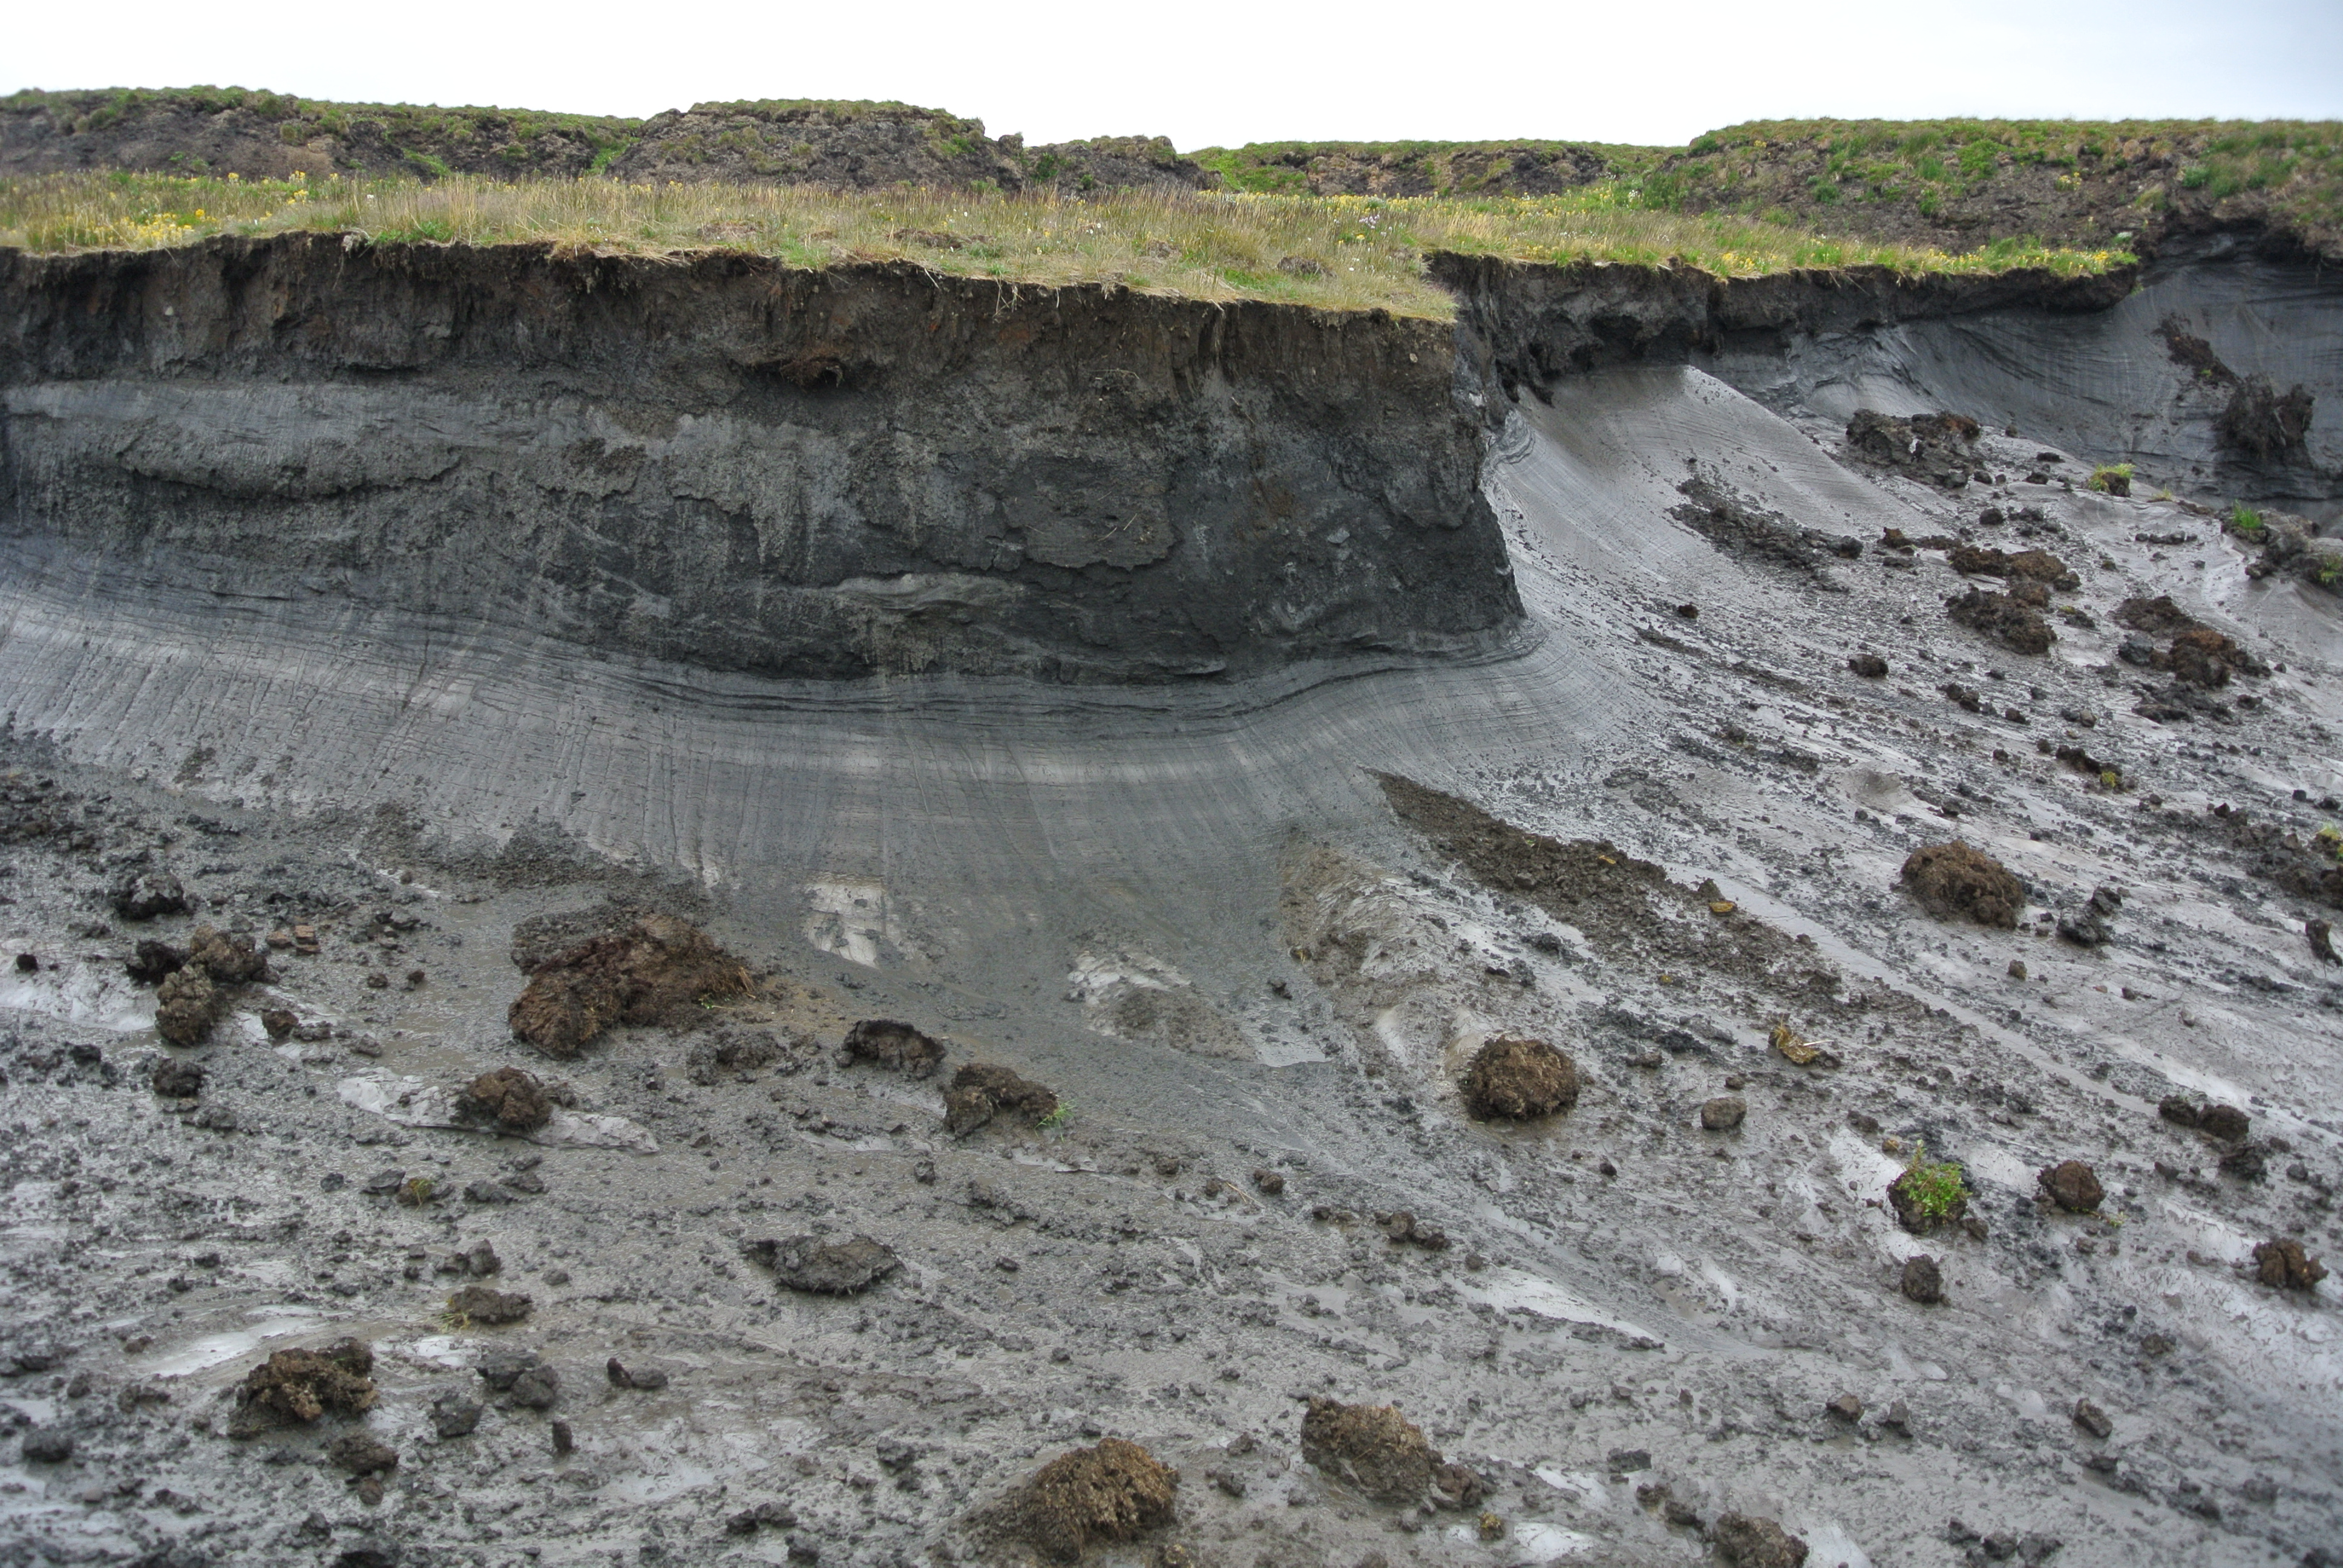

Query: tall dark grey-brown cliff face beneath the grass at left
[0,234,1521,680]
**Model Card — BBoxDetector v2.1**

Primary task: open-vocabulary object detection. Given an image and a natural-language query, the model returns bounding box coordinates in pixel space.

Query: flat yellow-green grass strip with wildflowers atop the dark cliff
[0,171,2132,319]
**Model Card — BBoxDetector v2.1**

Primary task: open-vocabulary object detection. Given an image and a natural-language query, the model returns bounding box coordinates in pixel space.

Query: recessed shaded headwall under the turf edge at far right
[1432,234,2343,520]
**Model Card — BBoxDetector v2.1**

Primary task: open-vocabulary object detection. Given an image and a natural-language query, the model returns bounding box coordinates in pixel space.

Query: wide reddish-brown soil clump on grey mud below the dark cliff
[508,914,752,1057]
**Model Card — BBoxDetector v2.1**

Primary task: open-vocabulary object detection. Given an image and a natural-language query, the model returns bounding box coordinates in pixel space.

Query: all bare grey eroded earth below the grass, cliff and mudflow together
[0,171,2343,1568]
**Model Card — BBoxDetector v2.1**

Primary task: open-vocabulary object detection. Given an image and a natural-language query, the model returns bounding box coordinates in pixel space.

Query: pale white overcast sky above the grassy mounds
[0,0,2343,148]
